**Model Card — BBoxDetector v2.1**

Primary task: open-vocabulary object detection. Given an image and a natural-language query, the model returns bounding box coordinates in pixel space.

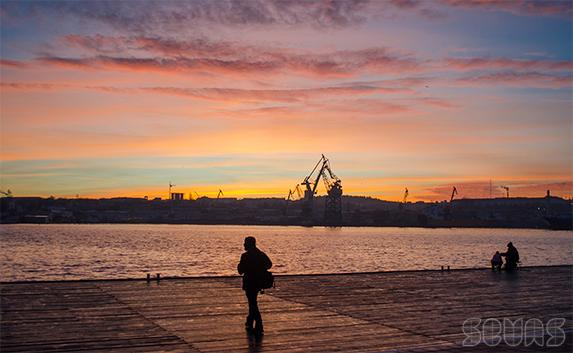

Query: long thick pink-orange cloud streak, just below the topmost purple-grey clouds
[38,35,423,76]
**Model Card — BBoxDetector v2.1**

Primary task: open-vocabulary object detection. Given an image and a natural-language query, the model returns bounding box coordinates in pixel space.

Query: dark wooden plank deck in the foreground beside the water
[0,266,573,352]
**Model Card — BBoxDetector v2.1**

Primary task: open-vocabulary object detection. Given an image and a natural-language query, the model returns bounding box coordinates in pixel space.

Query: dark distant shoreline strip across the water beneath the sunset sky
[0,195,573,230]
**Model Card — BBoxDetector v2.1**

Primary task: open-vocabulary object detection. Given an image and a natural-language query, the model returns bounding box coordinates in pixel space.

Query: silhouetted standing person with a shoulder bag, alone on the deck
[237,237,273,336]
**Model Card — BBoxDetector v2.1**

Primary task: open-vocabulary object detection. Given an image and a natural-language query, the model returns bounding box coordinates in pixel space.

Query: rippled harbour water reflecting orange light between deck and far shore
[0,224,573,281]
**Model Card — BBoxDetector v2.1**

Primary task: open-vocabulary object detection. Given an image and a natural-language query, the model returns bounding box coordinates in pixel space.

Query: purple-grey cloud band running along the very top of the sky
[0,0,573,38]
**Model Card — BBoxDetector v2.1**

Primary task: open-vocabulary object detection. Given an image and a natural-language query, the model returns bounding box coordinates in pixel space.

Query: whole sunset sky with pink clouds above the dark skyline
[0,0,573,201]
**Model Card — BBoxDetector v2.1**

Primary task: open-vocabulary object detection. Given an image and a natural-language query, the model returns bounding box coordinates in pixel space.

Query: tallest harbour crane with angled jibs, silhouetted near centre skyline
[300,154,342,226]
